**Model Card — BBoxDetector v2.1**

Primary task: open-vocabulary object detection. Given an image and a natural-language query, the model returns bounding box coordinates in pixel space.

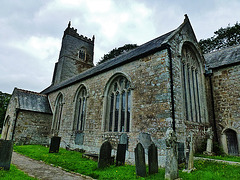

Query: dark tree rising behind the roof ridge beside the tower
[98,44,138,64]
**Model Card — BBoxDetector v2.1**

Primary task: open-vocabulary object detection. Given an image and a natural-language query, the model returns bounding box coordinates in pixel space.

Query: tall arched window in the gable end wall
[182,45,203,122]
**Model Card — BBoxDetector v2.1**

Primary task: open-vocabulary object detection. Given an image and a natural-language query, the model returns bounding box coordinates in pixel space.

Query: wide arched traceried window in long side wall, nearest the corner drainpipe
[106,76,131,132]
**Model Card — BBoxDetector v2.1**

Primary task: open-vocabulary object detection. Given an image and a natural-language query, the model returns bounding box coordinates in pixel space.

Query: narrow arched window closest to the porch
[52,93,63,134]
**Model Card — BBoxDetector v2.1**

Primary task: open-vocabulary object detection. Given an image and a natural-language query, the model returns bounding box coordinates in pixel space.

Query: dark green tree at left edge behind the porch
[0,91,11,128]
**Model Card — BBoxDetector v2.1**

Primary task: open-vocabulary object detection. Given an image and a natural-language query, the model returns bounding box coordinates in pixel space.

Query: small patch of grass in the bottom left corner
[0,165,35,180]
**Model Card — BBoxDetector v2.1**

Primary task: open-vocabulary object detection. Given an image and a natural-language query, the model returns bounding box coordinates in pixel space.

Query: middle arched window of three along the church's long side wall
[73,87,87,131]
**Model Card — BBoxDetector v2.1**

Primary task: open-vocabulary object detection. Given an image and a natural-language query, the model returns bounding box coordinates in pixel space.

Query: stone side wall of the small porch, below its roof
[14,111,52,145]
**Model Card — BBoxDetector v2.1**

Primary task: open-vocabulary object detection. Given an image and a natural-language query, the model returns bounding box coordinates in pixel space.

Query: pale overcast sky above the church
[0,0,240,93]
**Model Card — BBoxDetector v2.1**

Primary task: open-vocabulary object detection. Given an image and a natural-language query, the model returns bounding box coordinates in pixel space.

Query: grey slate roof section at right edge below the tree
[204,45,240,69]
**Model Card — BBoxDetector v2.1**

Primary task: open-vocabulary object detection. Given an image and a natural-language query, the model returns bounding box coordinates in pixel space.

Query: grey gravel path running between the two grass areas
[12,152,92,180]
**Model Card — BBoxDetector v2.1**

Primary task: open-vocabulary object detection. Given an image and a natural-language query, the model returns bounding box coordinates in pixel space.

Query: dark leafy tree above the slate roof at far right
[199,22,240,53]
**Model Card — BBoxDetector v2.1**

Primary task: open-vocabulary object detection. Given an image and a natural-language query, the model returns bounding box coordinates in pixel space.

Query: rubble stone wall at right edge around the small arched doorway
[212,64,240,154]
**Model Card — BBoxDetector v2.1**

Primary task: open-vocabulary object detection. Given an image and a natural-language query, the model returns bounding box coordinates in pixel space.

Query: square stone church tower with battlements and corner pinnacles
[52,22,95,85]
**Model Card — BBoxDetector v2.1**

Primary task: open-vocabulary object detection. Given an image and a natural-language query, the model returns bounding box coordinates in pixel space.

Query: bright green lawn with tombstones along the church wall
[14,145,240,180]
